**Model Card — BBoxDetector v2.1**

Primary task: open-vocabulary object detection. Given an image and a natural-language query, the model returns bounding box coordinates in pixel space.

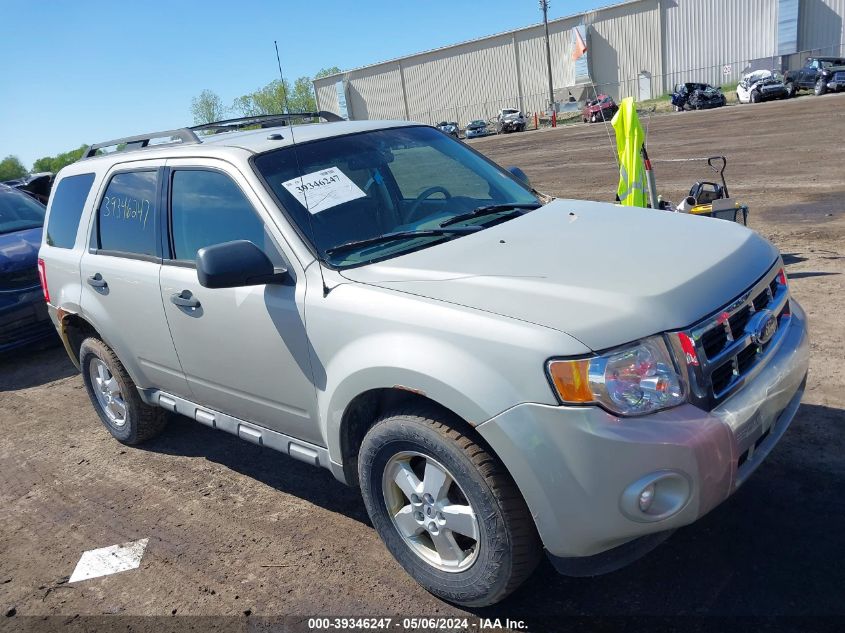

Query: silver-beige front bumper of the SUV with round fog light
[477,300,809,558]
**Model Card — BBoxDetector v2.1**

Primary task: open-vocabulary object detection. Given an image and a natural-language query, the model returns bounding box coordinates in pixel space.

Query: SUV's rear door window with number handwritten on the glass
[97,171,158,256]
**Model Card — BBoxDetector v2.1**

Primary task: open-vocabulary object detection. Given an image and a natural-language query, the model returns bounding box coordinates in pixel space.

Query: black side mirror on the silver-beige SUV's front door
[197,240,288,288]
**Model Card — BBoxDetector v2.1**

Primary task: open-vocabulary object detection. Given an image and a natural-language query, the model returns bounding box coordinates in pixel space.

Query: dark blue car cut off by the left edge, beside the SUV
[0,184,57,354]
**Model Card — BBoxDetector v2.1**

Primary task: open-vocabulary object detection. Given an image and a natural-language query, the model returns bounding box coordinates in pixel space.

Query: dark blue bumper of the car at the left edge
[0,286,55,353]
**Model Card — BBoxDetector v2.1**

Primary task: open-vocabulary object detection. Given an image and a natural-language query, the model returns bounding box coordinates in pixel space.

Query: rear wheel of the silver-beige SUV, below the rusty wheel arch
[79,337,168,446]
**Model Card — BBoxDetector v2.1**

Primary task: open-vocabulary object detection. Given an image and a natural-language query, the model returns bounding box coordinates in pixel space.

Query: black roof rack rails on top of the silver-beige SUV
[82,110,345,159]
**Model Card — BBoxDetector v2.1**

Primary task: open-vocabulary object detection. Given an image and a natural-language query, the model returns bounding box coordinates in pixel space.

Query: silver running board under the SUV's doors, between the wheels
[138,389,328,476]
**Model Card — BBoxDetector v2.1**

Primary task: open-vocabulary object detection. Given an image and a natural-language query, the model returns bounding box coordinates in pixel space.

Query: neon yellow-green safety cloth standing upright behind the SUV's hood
[610,97,646,207]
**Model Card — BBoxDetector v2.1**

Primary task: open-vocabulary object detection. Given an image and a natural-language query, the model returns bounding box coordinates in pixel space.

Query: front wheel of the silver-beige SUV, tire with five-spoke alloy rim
[358,405,542,607]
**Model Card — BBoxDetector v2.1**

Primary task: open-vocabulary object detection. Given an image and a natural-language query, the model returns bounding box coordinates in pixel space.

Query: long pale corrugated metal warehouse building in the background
[314,0,845,125]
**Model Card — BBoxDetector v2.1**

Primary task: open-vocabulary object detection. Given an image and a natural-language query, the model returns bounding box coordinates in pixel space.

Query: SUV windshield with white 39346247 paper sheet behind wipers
[254,126,539,268]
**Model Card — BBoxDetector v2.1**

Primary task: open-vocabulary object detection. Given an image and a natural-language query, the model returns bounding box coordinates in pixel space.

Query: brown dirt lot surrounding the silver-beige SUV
[0,95,845,622]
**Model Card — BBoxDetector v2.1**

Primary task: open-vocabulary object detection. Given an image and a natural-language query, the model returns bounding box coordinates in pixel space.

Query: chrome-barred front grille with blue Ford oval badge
[674,264,790,409]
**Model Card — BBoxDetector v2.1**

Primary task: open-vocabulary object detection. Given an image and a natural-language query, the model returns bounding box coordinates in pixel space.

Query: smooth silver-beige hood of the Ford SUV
[343,200,778,351]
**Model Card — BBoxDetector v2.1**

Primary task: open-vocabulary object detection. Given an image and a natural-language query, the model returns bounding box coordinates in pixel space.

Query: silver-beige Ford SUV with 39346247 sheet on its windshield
[39,114,809,606]
